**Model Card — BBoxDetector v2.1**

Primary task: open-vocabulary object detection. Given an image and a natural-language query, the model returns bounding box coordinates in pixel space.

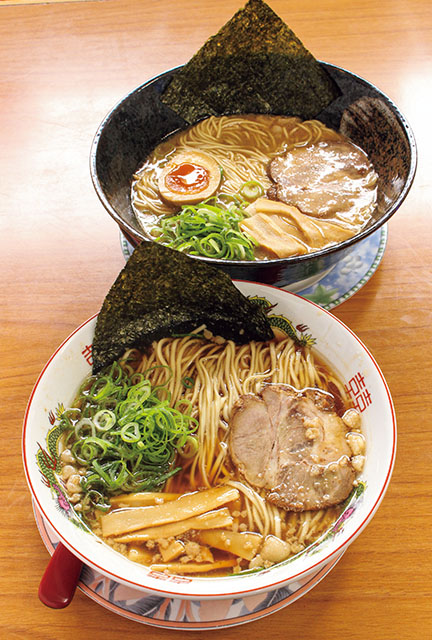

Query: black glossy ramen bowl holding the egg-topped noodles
[90,62,417,287]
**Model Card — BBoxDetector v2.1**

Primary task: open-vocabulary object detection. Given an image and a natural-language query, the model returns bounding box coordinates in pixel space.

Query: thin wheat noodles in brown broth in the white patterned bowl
[124,337,347,549]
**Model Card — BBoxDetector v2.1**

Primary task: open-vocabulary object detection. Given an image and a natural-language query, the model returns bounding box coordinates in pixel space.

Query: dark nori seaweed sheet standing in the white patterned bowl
[92,242,273,373]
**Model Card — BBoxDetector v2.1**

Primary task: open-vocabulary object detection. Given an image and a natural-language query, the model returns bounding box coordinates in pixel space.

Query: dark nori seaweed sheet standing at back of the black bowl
[161,0,340,123]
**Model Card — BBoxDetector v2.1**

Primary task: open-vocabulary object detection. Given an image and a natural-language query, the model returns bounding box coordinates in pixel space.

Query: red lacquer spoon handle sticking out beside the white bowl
[39,542,82,609]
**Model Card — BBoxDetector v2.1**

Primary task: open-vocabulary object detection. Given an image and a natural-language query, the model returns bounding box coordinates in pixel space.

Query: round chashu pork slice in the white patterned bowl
[228,385,356,511]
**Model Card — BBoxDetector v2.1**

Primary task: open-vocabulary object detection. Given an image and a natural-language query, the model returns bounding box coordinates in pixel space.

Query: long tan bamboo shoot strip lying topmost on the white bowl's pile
[101,487,239,537]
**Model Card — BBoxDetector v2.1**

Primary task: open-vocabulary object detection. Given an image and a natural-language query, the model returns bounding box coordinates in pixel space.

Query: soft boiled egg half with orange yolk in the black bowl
[158,149,221,205]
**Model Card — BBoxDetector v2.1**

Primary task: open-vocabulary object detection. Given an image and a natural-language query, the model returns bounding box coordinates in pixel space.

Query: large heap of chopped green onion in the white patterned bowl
[56,363,198,519]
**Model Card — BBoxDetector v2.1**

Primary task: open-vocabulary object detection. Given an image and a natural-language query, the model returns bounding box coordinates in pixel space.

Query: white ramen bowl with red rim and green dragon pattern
[23,282,396,600]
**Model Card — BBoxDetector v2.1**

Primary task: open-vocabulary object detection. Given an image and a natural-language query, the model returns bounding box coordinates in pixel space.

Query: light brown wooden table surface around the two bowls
[0,0,432,640]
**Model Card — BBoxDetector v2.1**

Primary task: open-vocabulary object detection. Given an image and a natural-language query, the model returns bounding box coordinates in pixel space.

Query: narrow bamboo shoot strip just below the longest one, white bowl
[111,507,233,544]
